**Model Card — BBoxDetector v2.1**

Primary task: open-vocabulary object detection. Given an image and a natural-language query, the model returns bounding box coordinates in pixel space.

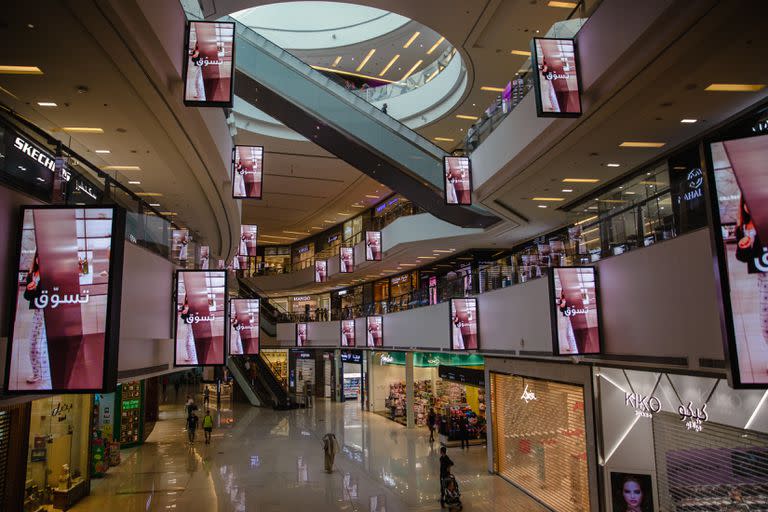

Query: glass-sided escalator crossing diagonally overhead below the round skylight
[222,18,499,228]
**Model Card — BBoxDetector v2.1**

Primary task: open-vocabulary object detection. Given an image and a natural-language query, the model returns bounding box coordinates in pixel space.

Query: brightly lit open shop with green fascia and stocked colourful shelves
[369,351,485,432]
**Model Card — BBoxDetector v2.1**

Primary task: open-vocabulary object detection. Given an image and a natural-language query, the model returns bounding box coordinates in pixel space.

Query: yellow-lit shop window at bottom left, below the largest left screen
[24,395,93,510]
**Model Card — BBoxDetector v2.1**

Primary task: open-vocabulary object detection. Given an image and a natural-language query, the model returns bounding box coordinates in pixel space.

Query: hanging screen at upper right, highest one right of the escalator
[531,37,581,117]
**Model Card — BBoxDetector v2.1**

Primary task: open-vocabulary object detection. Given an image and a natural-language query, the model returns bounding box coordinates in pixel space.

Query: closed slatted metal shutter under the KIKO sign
[653,412,768,512]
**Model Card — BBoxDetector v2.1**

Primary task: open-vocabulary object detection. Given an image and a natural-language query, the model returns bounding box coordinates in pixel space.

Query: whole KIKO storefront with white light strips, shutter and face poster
[595,368,768,512]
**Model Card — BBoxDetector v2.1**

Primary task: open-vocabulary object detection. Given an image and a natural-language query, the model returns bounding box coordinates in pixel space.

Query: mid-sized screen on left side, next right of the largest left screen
[174,270,227,366]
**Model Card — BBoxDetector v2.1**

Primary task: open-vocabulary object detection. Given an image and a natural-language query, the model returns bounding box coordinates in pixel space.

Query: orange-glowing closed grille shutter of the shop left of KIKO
[491,373,592,512]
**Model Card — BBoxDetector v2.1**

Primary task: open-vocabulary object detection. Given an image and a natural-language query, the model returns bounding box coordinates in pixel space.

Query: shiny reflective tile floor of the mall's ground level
[71,390,543,512]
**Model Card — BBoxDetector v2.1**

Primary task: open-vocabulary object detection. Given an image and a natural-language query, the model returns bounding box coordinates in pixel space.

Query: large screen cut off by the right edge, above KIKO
[709,135,768,387]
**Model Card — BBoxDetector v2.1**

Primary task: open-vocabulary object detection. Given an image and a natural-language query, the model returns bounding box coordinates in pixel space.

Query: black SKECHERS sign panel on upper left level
[0,125,56,200]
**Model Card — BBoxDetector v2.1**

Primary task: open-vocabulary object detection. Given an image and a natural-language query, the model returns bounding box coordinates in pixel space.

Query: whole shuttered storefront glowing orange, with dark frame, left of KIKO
[485,358,600,512]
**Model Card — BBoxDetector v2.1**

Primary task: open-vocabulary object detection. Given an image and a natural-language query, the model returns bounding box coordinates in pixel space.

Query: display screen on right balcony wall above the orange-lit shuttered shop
[550,267,600,356]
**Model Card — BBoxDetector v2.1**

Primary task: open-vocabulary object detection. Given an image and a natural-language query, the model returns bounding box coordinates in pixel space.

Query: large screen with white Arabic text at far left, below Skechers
[5,206,125,394]
